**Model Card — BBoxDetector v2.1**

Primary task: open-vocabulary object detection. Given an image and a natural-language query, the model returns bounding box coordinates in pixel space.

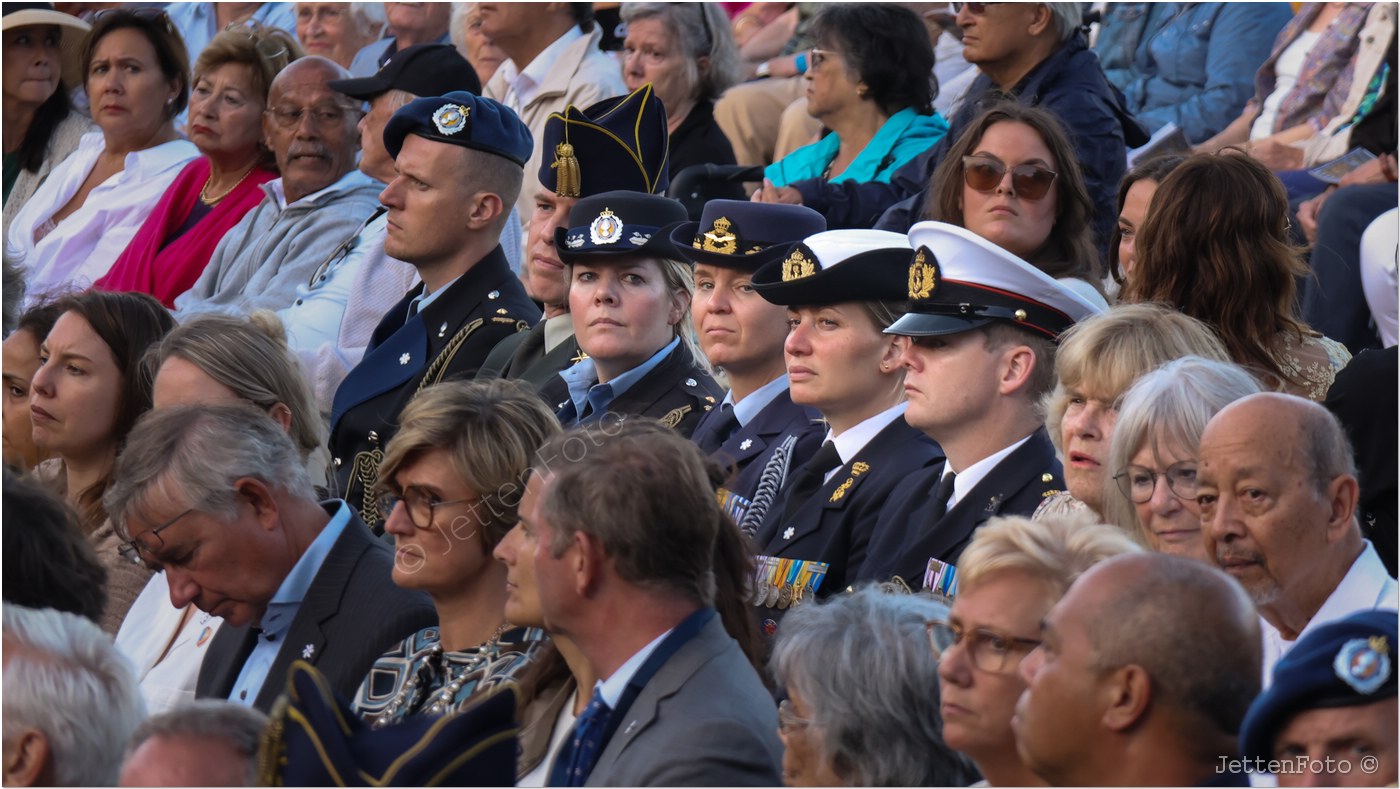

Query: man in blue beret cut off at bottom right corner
[1240,609,1400,786]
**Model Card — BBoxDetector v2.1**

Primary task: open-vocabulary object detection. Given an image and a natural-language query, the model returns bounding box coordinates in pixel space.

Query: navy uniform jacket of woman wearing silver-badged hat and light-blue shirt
[539,343,724,438]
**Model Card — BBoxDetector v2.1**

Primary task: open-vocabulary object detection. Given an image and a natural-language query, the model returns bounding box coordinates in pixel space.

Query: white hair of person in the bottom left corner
[0,603,146,786]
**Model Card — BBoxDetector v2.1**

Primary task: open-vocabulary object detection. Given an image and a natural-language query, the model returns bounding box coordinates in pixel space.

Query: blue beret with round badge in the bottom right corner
[1240,609,1400,760]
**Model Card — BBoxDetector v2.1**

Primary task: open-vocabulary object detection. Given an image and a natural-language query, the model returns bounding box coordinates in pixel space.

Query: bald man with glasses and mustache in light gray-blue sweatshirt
[175,56,382,320]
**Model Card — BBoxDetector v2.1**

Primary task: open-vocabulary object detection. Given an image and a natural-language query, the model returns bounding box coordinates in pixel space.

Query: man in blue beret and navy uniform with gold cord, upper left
[330,91,538,529]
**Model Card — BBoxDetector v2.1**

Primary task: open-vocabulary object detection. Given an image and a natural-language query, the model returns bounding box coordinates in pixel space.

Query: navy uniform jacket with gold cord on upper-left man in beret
[330,246,539,530]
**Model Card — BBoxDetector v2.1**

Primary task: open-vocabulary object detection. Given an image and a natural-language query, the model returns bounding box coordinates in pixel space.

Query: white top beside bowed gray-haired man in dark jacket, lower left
[116,572,224,715]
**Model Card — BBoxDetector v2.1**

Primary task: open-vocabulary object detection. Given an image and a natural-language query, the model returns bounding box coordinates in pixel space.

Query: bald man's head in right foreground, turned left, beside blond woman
[1011,553,1260,786]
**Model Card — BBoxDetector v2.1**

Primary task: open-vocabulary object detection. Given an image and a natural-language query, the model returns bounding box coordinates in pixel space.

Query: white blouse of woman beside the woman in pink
[6,132,199,302]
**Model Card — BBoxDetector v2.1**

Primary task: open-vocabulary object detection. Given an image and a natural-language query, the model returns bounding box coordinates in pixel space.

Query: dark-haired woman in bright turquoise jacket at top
[757,3,948,191]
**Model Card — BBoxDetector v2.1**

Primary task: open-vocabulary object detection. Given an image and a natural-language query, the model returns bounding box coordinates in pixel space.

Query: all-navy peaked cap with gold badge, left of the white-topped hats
[671,200,826,271]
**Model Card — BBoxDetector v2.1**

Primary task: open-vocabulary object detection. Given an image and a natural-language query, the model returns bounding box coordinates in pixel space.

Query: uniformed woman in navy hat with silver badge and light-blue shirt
[540,192,724,436]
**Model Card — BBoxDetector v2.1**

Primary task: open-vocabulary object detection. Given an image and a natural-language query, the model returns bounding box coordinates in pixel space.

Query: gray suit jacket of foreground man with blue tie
[588,616,783,786]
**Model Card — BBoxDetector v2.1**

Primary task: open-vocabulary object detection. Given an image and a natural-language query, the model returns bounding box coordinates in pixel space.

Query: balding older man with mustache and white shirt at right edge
[1197,393,1396,687]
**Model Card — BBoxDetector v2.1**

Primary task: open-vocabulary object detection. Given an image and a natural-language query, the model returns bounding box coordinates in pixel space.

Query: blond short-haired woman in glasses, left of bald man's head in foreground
[928,516,1142,786]
